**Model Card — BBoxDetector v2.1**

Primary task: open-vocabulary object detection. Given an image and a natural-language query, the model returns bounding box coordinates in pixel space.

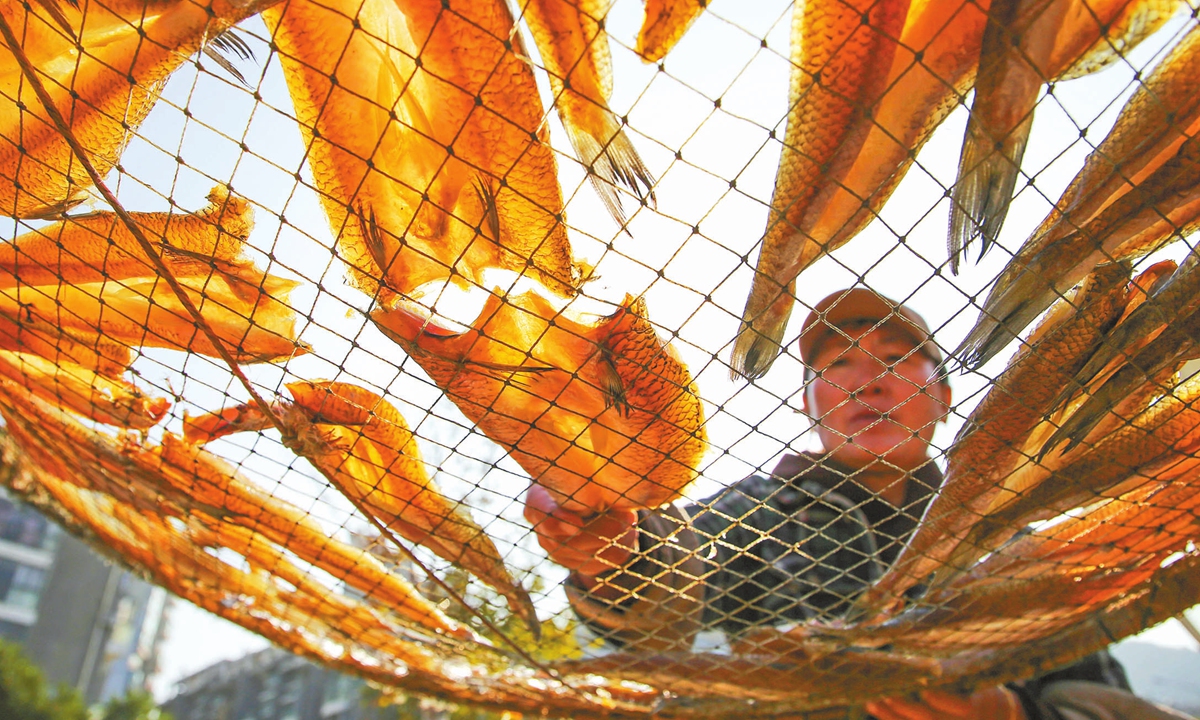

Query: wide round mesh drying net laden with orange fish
[0,0,1200,718]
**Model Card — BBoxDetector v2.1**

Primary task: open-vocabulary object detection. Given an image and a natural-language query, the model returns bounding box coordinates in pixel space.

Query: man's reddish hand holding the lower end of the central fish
[524,485,637,578]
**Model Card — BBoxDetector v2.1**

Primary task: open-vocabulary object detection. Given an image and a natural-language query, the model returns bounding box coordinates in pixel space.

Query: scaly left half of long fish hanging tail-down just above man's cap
[730,0,910,379]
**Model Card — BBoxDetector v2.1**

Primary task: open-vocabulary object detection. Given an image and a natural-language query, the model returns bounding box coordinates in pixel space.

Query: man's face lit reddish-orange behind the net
[805,322,950,470]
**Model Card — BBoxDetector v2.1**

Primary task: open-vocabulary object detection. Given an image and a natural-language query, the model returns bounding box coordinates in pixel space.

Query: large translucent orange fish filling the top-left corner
[0,0,276,218]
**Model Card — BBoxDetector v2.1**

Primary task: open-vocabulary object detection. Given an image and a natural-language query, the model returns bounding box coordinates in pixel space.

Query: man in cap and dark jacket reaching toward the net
[526,288,1190,720]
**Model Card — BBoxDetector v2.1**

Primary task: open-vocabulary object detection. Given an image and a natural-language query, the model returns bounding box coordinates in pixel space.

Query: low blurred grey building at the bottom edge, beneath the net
[162,647,397,720]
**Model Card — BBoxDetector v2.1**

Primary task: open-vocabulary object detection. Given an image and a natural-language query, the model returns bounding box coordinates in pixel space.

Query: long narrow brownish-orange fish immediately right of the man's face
[859,264,1129,608]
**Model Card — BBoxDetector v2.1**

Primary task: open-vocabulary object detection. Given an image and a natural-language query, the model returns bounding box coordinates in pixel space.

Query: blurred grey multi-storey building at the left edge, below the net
[0,488,168,703]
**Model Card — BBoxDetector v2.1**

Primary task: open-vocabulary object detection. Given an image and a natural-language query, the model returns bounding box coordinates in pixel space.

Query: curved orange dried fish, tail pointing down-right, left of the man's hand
[184,382,541,636]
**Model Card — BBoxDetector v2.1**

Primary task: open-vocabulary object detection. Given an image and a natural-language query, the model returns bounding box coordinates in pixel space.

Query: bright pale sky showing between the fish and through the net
[4,0,1200,696]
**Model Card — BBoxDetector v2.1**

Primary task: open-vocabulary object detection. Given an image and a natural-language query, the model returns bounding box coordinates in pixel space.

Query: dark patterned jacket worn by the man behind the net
[568,454,1128,720]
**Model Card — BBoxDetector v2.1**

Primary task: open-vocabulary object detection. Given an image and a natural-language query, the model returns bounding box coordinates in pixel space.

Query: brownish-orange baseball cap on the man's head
[799,287,942,367]
